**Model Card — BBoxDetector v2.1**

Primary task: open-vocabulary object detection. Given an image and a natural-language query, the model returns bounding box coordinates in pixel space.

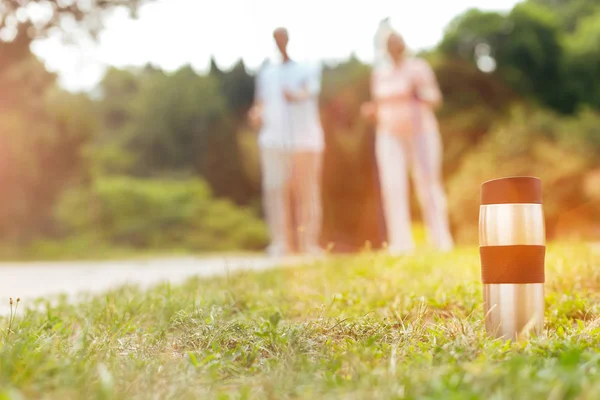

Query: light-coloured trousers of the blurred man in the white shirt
[261,148,323,255]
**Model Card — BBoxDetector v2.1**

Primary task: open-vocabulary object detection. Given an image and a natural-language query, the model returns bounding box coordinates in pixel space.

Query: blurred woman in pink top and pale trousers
[361,31,454,254]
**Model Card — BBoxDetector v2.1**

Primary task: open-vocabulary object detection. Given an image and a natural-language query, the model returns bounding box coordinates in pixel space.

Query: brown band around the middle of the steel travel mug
[479,245,546,284]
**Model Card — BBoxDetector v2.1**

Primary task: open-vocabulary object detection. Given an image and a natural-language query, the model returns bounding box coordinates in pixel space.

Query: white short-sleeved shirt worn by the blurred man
[256,61,324,151]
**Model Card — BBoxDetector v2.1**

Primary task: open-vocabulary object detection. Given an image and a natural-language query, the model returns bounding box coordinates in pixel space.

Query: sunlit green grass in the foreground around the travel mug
[0,246,600,400]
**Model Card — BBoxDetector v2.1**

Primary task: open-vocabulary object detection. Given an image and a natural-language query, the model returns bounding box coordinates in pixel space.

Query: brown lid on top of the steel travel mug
[481,176,542,205]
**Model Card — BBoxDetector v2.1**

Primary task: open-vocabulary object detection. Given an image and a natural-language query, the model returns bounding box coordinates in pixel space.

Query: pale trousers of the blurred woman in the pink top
[375,132,454,253]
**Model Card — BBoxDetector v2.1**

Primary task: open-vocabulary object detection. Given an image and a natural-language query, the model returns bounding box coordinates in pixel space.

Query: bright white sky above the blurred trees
[33,0,518,91]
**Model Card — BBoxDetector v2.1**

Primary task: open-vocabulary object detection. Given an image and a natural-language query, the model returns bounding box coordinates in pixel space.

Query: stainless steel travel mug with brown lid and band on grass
[479,177,546,340]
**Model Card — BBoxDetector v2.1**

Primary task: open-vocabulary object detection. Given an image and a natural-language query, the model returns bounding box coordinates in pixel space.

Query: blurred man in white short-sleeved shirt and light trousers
[249,28,324,256]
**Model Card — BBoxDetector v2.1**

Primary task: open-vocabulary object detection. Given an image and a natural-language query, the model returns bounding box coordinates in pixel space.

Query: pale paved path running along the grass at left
[0,256,310,314]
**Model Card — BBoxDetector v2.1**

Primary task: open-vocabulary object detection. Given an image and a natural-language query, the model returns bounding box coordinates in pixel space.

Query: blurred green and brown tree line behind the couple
[0,0,600,256]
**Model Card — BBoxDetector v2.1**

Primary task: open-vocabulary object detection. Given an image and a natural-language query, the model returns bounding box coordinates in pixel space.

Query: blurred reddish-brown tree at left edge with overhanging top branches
[0,0,155,247]
